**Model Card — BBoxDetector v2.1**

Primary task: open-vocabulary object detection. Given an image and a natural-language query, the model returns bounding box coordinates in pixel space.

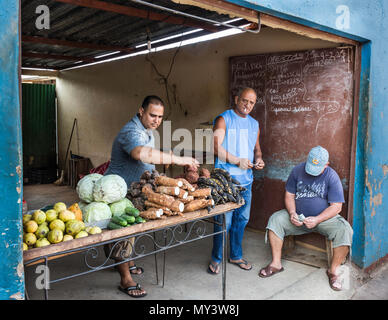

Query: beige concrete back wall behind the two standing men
[57,28,336,175]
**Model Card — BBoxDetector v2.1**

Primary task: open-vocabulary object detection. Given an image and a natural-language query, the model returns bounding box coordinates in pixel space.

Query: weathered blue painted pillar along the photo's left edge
[0,0,24,300]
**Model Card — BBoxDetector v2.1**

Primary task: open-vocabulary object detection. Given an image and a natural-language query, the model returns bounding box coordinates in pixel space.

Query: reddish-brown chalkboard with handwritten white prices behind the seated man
[229,47,354,244]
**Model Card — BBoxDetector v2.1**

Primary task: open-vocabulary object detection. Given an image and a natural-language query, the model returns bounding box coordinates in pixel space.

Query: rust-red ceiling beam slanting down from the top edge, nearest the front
[55,0,219,32]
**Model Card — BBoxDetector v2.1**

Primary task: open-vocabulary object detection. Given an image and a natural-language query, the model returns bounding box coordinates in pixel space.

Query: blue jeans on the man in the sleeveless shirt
[212,184,252,263]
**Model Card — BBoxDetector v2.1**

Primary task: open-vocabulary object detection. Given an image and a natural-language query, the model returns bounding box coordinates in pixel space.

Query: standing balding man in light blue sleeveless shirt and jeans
[207,88,264,274]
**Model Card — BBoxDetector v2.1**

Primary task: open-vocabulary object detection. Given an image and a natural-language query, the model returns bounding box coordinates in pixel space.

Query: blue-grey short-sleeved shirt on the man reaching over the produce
[105,115,155,188]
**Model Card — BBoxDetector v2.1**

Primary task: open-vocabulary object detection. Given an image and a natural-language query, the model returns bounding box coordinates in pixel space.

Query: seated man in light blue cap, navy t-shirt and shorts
[259,146,353,291]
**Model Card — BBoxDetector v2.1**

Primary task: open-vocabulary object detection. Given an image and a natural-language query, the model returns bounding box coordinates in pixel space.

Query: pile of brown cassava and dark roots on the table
[127,168,245,220]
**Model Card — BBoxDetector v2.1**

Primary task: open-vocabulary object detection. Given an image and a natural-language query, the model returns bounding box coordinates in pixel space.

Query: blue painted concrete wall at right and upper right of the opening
[227,0,388,268]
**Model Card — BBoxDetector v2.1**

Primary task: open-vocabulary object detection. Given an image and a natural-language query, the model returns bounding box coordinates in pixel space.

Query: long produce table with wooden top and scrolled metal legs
[23,202,242,299]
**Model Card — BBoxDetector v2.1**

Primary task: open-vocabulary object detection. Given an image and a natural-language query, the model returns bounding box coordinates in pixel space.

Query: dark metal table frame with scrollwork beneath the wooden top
[24,211,228,300]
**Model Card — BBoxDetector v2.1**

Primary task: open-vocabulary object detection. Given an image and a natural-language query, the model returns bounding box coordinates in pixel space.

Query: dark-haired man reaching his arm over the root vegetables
[104,95,199,298]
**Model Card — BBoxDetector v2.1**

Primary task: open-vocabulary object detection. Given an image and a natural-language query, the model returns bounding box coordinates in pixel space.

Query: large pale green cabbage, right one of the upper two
[93,174,128,203]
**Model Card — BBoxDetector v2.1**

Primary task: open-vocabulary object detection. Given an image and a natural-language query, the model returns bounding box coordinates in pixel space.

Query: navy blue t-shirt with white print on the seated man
[286,162,345,217]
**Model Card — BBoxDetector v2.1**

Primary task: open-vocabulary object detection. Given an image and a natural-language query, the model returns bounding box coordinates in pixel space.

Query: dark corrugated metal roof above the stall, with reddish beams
[21,0,255,69]
